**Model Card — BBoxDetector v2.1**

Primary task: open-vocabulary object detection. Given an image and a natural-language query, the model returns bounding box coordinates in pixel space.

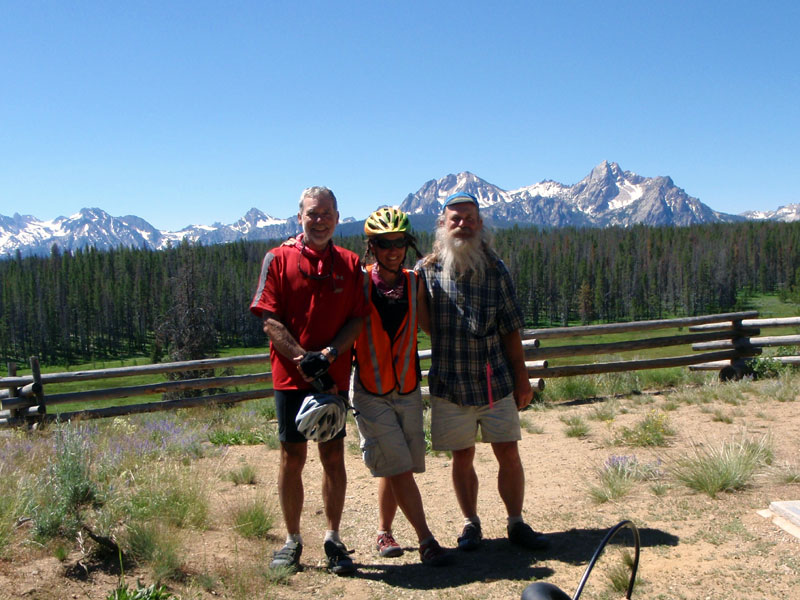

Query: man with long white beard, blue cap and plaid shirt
[418,192,548,551]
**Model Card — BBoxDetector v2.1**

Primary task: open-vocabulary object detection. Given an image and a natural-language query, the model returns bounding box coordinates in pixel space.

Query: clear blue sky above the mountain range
[0,0,800,230]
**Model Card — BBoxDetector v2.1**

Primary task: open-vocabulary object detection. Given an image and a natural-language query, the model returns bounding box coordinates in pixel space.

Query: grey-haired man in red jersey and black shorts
[250,187,369,575]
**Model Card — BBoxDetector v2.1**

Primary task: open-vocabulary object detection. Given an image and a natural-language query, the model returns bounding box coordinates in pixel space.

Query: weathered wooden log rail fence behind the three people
[0,311,800,426]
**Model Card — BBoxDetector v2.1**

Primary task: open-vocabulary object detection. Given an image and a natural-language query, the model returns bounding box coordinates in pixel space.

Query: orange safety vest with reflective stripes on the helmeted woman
[355,265,419,396]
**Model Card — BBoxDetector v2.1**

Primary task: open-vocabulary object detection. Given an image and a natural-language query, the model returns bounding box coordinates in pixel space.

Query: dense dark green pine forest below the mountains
[0,222,800,366]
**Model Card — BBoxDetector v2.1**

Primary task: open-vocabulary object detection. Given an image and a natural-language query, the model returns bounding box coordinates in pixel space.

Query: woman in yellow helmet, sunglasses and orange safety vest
[351,207,448,566]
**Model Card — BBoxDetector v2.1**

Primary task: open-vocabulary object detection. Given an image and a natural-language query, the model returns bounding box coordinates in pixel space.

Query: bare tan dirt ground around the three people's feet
[0,384,800,600]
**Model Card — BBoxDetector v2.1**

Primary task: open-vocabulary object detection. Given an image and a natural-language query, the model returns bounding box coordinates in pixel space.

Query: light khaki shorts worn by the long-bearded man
[431,393,522,450]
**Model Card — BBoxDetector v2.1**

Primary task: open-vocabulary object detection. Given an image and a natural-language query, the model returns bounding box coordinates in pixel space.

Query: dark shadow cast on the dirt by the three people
[348,529,678,590]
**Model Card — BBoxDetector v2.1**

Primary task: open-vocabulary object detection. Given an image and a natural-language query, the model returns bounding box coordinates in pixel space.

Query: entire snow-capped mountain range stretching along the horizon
[0,162,800,257]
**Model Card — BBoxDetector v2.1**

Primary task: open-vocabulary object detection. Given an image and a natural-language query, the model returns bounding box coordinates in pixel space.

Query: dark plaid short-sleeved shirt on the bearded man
[420,253,525,406]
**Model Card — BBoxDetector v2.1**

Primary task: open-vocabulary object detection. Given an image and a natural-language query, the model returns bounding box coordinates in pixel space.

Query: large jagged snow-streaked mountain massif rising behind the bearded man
[400,162,742,227]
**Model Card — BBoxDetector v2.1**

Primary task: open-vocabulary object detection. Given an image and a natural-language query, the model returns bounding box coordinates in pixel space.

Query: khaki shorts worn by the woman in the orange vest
[351,377,425,477]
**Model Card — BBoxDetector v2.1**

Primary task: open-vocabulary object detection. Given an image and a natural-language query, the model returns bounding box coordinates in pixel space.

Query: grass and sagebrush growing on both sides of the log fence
[0,297,800,600]
